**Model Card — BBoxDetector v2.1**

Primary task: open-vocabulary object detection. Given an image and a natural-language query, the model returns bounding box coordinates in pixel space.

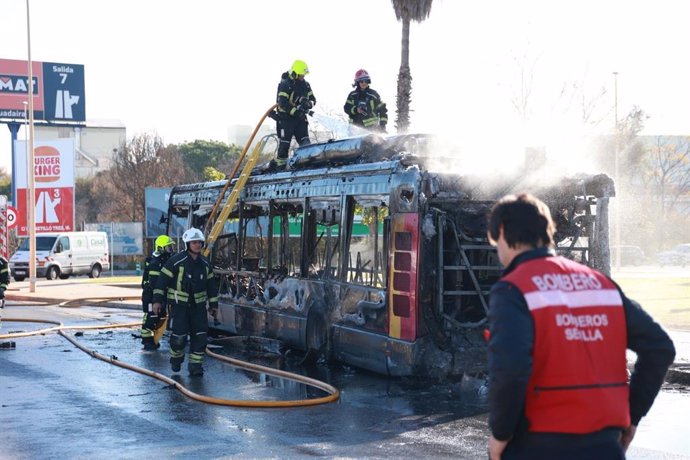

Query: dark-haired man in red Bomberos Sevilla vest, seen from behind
[489,194,675,460]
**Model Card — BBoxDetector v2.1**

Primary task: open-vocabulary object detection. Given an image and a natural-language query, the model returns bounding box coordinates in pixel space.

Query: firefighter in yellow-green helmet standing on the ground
[141,235,175,351]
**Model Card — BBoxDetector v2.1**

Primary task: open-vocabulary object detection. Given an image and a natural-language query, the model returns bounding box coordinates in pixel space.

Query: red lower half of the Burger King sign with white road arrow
[17,188,74,236]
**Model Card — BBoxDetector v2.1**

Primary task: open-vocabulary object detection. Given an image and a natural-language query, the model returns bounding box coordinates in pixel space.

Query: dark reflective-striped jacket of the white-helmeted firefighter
[153,251,218,310]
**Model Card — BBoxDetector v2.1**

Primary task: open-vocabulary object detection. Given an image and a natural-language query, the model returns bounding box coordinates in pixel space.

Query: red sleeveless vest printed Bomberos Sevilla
[502,257,630,434]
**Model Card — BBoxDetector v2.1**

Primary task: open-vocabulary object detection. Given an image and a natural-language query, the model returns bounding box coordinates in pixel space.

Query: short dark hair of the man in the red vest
[488,193,556,248]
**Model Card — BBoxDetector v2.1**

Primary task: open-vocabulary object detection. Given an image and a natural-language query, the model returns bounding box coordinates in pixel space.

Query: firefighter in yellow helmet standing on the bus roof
[275,60,316,168]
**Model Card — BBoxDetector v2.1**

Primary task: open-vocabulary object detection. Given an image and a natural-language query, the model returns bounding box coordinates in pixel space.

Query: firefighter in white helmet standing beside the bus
[153,228,218,376]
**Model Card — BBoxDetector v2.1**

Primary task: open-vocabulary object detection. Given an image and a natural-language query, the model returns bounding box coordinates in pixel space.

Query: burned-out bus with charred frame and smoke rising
[168,134,614,378]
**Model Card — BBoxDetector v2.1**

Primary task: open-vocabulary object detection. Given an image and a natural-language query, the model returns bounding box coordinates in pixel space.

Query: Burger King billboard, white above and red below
[13,139,74,236]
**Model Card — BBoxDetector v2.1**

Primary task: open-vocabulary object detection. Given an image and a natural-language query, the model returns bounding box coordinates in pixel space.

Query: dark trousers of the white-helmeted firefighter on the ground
[170,303,208,364]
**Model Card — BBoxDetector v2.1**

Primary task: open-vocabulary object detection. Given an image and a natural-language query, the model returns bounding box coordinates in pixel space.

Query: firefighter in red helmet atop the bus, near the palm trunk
[343,69,388,133]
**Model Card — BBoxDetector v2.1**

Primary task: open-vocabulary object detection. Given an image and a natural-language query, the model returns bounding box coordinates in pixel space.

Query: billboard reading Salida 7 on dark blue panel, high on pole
[0,59,86,122]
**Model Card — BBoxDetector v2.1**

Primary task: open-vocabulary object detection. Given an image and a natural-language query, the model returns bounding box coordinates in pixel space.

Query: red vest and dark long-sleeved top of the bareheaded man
[489,248,675,440]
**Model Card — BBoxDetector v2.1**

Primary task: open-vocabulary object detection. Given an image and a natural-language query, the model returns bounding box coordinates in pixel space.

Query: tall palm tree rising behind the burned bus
[391,0,432,133]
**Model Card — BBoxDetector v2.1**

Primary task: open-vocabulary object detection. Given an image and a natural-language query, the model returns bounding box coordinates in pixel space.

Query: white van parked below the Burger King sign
[10,232,110,281]
